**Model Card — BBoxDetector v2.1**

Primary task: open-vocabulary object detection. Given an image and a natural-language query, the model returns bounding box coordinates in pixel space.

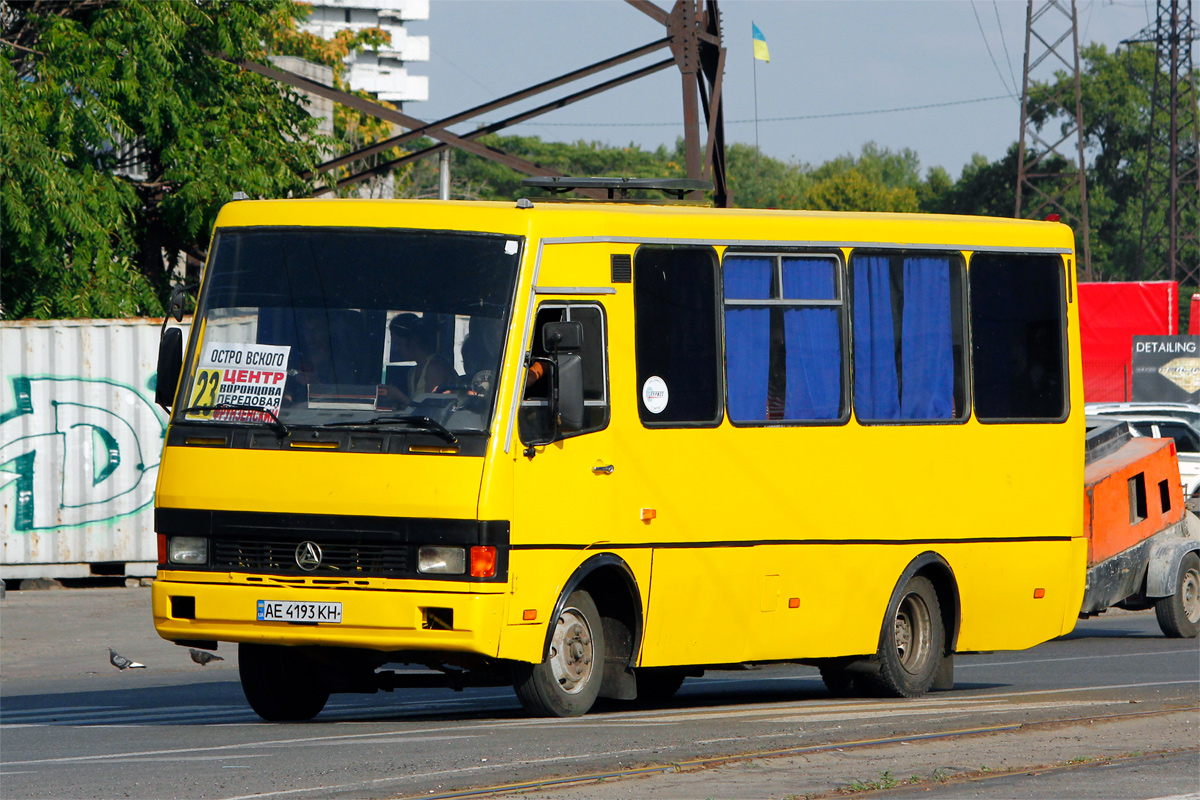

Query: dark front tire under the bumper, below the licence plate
[238,643,329,722]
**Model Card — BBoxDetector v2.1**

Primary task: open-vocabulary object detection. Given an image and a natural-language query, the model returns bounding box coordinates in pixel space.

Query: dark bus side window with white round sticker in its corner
[634,247,724,427]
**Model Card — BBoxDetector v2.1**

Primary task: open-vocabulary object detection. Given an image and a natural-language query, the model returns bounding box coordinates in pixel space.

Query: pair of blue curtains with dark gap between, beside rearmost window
[854,255,954,420]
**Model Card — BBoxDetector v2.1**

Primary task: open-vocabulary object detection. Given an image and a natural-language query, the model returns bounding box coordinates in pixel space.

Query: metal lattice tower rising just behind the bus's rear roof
[1015,0,1092,281]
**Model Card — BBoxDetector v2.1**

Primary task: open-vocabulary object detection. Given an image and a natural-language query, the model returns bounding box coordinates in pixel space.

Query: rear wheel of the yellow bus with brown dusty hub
[869,576,946,697]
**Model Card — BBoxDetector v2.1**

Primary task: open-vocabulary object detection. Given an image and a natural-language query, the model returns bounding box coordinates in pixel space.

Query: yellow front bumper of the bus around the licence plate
[151,579,506,656]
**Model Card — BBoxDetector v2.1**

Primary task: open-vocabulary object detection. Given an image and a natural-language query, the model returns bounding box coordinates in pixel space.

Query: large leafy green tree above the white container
[0,0,318,318]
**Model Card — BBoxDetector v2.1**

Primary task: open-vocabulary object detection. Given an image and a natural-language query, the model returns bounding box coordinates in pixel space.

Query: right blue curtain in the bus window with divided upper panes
[784,258,841,420]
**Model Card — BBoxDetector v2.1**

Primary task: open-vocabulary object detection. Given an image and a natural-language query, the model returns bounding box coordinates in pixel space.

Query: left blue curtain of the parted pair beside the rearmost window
[854,255,900,420]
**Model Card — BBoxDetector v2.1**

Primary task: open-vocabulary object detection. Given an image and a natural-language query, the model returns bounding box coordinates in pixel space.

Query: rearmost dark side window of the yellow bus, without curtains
[970,253,1067,421]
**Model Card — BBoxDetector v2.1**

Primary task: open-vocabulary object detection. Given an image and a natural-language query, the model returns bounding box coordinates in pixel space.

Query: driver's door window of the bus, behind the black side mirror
[517,303,608,444]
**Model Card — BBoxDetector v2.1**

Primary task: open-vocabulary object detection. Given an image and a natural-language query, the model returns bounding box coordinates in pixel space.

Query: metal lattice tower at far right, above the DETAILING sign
[1129,0,1200,287]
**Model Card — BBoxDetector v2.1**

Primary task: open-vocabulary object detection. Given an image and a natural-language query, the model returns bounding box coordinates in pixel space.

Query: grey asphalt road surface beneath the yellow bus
[0,589,1200,798]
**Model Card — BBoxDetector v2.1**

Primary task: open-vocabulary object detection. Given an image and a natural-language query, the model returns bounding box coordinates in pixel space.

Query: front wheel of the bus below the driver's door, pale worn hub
[512,590,605,717]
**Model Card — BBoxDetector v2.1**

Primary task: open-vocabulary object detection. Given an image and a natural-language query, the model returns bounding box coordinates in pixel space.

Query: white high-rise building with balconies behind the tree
[301,0,430,103]
